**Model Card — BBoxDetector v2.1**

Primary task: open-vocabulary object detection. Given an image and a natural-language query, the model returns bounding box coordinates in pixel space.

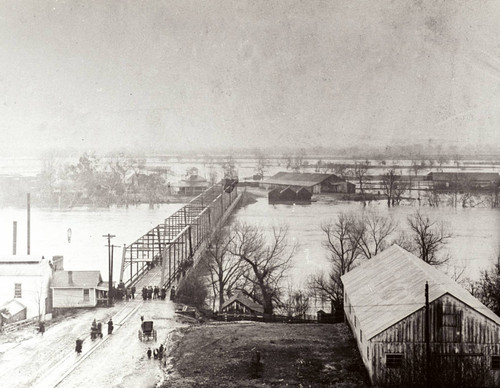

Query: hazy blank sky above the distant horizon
[0,0,500,153]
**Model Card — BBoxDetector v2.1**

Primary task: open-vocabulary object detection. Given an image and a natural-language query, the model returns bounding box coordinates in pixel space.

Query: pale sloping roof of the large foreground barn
[342,245,500,339]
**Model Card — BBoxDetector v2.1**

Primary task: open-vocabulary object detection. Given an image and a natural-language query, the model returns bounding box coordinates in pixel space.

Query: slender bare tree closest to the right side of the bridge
[205,229,243,309]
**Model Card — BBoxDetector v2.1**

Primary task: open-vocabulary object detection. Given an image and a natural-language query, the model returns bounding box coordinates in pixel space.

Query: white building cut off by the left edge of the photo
[0,255,52,319]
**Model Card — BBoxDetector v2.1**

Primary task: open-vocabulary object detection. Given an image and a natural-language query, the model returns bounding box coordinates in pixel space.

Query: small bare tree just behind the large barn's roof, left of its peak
[358,212,397,259]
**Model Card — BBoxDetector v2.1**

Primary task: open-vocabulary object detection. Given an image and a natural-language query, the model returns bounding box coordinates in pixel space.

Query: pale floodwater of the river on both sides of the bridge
[0,197,500,287]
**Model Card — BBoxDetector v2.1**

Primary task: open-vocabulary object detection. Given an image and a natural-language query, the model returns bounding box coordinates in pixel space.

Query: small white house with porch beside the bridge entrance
[51,271,108,309]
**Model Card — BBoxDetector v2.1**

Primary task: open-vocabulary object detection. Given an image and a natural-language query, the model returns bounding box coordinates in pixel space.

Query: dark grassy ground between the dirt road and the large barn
[161,322,368,388]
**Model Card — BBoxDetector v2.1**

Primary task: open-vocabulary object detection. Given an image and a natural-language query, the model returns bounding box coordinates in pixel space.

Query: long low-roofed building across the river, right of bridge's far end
[261,172,356,194]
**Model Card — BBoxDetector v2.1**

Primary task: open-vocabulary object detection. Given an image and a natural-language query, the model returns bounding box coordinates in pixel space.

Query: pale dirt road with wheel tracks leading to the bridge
[0,299,185,388]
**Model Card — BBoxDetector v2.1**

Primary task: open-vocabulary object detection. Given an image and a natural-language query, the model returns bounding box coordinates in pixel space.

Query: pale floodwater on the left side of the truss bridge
[0,204,183,279]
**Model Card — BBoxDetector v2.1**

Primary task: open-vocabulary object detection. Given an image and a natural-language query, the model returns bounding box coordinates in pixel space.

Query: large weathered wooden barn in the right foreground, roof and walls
[342,245,500,387]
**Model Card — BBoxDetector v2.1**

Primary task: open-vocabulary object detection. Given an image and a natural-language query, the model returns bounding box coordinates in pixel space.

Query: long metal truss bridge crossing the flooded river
[120,179,242,289]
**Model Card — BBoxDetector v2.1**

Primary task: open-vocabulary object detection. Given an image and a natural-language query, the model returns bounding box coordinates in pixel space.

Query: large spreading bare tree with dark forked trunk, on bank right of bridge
[230,224,297,314]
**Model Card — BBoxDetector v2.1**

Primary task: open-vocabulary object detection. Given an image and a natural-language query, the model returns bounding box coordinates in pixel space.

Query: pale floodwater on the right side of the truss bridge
[232,197,500,287]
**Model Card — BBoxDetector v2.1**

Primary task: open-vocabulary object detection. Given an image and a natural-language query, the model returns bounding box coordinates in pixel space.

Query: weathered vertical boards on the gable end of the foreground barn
[368,294,500,386]
